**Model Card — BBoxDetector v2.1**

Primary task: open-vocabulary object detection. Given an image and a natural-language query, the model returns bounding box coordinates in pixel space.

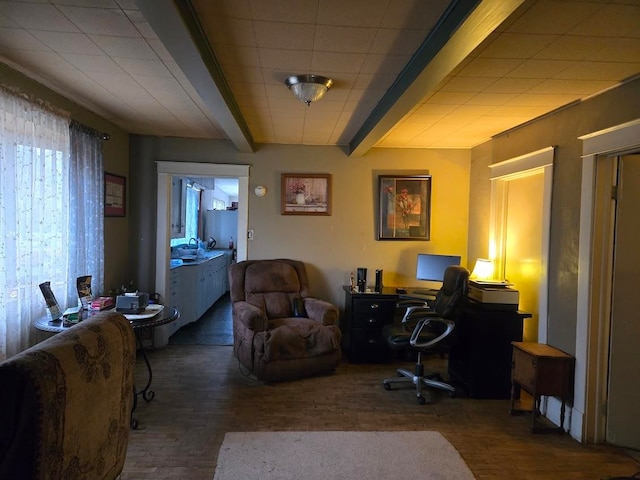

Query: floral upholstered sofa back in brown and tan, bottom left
[0,312,136,480]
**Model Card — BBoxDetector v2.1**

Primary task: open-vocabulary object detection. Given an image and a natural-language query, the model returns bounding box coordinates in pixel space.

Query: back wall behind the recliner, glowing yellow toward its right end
[131,136,470,307]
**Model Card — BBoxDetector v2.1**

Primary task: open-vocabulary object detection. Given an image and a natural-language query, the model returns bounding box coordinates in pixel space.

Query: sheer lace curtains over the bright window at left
[0,87,104,360]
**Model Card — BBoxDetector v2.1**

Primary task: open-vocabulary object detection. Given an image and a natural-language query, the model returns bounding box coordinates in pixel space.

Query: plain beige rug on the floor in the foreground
[213,432,475,480]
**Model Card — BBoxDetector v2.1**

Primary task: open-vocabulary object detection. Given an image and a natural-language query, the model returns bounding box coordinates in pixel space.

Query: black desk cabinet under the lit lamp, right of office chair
[449,304,531,399]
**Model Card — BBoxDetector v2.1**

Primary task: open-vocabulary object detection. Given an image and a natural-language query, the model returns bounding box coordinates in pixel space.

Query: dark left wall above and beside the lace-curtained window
[0,63,132,293]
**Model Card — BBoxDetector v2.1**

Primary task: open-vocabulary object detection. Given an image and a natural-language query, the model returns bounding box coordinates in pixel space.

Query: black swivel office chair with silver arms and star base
[382,265,469,405]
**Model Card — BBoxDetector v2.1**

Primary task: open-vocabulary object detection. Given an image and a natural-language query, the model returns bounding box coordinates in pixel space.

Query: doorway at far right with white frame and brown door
[574,119,640,448]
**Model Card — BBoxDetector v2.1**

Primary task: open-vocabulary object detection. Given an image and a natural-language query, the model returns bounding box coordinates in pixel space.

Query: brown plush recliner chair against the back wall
[229,259,342,382]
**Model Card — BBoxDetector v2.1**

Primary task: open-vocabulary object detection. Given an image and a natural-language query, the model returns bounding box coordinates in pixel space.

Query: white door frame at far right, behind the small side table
[572,119,640,443]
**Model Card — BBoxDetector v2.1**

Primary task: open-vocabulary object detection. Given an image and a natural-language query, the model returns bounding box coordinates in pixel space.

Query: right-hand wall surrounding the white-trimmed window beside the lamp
[469,79,640,354]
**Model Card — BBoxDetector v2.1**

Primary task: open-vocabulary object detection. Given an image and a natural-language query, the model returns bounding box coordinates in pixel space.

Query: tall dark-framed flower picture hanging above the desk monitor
[378,175,431,240]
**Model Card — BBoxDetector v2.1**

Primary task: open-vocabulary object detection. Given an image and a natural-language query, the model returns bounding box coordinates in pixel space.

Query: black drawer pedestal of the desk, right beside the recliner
[342,286,398,363]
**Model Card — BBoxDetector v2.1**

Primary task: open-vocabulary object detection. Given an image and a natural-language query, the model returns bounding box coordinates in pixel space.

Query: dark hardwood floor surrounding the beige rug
[121,301,640,480]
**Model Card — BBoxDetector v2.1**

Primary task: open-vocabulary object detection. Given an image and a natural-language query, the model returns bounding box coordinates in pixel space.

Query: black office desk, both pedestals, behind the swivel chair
[341,286,531,398]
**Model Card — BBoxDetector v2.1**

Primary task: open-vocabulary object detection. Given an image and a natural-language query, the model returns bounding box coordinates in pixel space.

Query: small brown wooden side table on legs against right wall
[511,342,575,433]
